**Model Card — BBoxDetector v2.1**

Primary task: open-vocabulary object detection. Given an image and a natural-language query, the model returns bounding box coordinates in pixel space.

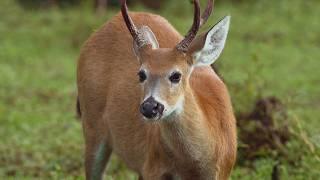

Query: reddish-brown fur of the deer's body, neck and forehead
[77,13,237,180]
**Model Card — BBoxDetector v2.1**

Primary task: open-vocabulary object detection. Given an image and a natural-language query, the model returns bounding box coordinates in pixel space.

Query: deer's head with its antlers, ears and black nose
[121,0,230,120]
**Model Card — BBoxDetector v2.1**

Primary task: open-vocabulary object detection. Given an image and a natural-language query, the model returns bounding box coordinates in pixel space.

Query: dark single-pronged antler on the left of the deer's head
[120,0,139,41]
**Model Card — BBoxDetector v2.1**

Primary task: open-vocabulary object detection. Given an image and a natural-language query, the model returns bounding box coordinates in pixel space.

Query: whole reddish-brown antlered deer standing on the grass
[77,0,237,180]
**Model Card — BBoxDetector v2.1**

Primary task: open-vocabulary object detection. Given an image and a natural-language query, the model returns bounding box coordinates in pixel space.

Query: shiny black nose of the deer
[140,96,164,119]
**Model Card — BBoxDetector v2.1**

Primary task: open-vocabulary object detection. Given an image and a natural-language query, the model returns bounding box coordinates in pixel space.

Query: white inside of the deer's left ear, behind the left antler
[133,26,159,55]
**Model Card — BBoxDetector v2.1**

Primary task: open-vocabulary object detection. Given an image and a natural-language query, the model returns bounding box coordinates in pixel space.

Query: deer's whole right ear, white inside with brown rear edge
[188,16,230,66]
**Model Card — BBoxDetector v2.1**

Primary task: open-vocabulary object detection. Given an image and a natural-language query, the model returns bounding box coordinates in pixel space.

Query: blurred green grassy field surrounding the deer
[0,0,320,180]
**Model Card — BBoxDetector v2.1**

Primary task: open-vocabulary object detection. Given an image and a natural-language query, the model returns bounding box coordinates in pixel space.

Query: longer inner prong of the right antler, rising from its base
[176,0,200,52]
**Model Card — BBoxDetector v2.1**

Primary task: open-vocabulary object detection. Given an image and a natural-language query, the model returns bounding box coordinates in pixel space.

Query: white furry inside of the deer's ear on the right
[193,16,230,66]
